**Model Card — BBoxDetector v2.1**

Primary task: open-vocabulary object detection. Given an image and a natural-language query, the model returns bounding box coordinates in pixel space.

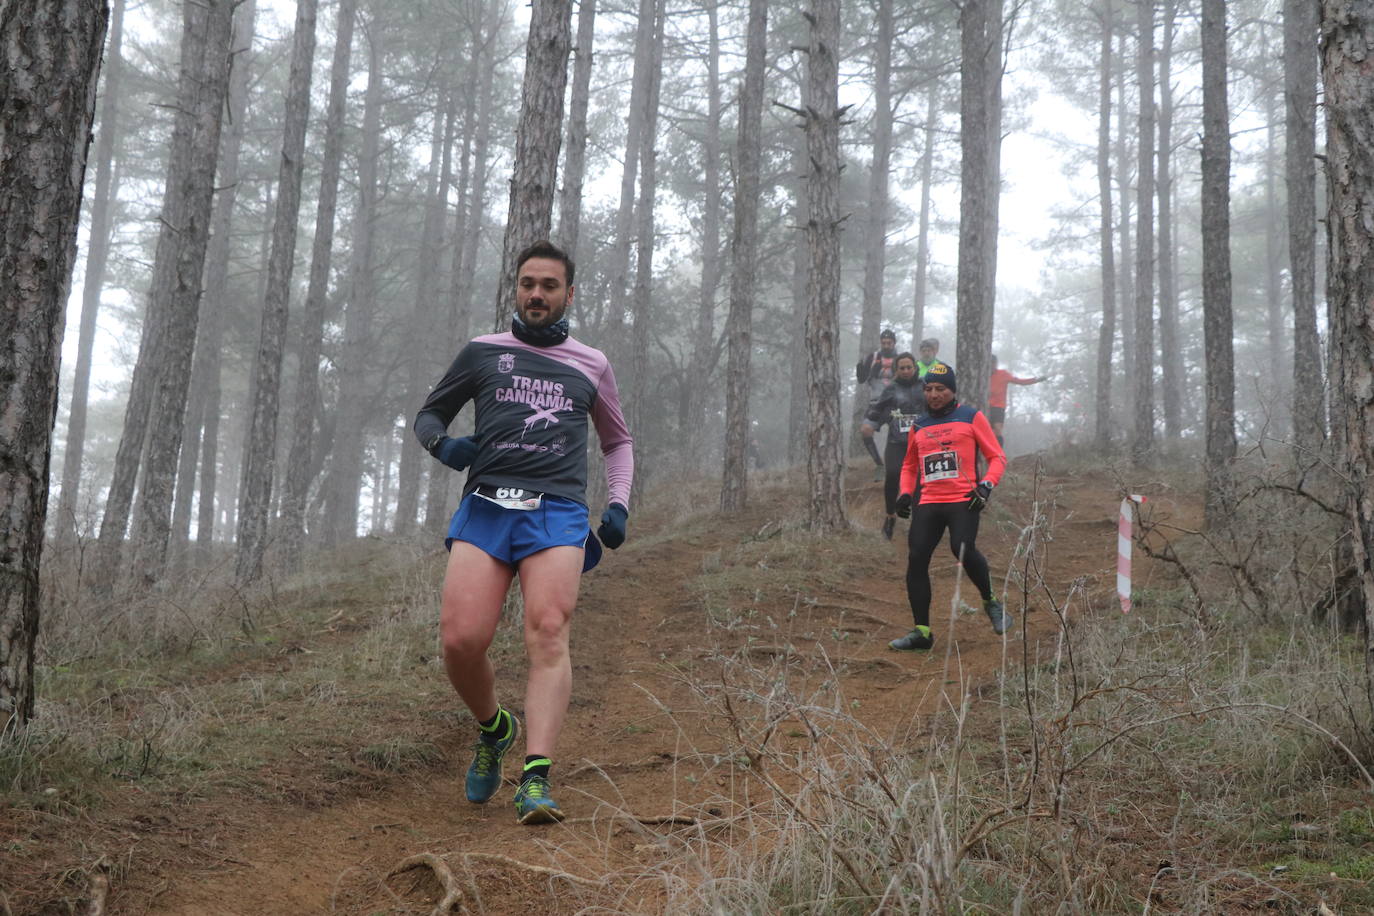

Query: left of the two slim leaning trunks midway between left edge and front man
[234,0,317,588]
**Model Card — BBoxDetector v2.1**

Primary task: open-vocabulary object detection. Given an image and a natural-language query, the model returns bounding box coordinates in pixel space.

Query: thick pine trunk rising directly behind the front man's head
[496,0,573,327]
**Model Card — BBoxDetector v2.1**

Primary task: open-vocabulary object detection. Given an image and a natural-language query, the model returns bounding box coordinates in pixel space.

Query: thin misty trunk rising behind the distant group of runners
[849,0,892,455]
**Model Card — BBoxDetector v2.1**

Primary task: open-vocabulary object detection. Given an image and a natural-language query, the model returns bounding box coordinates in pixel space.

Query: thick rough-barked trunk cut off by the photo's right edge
[1324,0,1374,702]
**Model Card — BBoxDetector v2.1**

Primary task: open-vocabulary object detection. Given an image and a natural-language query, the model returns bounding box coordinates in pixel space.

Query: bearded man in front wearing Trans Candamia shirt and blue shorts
[415,242,633,824]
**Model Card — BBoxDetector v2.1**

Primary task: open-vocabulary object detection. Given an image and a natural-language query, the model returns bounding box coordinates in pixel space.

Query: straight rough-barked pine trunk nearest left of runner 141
[807,0,849,533]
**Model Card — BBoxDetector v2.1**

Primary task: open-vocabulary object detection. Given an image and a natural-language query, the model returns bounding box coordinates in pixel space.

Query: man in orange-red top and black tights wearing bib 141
[888,363,1011,651]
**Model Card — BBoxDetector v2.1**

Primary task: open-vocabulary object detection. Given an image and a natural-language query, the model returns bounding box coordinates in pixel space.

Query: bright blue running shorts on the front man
[444,493,602,573]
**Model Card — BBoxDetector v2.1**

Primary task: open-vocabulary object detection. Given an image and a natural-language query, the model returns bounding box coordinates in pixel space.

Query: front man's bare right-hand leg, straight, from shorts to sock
[519,547,583,757]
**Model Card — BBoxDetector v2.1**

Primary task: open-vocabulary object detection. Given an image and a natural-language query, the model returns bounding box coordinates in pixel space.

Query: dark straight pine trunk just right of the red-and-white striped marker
[1202,0,1235,527]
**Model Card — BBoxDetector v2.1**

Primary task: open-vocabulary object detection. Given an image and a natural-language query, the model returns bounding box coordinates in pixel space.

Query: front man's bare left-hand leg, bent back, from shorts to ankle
[438,541,516,721]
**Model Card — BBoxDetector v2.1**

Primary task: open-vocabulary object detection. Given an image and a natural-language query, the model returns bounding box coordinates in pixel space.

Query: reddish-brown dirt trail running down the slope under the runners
[126,461,1118,916]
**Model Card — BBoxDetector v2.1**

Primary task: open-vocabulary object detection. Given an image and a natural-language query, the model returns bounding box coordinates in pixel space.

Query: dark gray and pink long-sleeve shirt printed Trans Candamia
[415,331,635,508]
